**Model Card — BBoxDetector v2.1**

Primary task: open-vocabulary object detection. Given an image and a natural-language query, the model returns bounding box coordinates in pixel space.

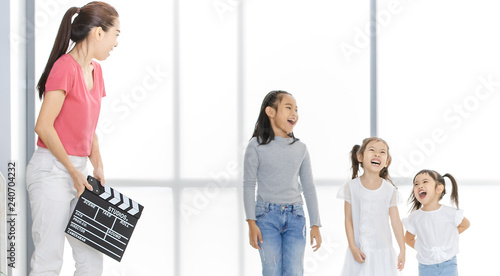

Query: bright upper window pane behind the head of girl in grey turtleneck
[244,1,370,183]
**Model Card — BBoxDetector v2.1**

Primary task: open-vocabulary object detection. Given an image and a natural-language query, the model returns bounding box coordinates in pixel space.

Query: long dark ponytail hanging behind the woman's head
[37,7,80,99]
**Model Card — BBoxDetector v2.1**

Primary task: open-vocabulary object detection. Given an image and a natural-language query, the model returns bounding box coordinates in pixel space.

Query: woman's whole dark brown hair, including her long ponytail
[37,2,118,99]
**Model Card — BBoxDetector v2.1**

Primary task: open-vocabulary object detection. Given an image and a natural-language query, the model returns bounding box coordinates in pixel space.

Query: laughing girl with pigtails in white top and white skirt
[337,137,405,276]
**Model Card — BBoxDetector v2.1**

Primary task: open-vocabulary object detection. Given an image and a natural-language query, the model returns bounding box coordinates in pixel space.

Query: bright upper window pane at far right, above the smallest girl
[378,0,500,183]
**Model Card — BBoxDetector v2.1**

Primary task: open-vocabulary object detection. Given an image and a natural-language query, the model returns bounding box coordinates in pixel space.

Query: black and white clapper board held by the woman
[66,175,144,261]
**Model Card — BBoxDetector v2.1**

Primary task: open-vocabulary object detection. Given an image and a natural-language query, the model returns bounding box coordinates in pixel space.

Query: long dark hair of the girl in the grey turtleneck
[252,90,299,145]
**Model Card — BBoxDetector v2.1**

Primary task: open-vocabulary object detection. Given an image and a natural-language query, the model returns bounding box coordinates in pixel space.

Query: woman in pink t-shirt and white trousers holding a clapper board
[26,2,120,276]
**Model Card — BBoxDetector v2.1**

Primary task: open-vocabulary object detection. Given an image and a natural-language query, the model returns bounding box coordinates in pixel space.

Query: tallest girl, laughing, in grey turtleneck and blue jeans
[243,91,321,275]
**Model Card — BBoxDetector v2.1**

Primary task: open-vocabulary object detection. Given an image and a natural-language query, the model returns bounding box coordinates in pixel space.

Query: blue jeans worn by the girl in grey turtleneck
[255,202,306,276]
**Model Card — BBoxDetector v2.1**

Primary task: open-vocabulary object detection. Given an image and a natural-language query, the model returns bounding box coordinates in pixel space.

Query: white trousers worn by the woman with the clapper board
[26,147,103,276]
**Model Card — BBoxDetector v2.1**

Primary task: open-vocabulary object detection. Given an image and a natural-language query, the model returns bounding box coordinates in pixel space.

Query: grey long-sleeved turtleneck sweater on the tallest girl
[243,136,321,226]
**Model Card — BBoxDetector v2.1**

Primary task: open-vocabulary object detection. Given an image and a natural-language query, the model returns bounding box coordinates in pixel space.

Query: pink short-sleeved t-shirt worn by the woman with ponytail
[37,54,106,156]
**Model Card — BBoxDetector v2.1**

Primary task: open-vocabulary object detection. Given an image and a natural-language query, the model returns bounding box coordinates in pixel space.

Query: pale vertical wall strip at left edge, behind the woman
[0,1,27,275]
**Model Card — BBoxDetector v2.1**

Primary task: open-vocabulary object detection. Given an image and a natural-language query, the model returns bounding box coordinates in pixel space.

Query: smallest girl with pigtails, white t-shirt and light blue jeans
[403,170,470,276]
